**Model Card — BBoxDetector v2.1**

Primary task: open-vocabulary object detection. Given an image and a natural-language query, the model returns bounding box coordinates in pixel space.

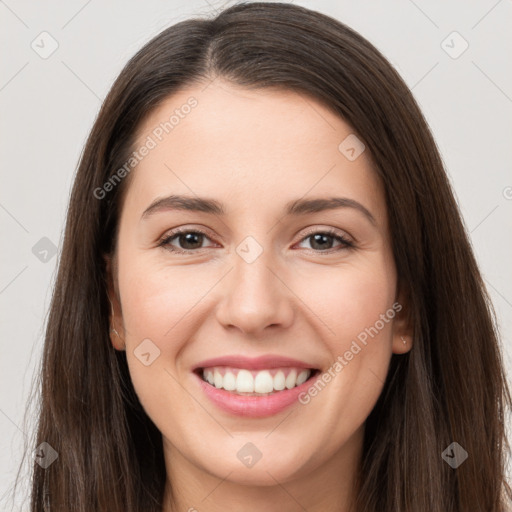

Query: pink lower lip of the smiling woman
[194,373,320,418]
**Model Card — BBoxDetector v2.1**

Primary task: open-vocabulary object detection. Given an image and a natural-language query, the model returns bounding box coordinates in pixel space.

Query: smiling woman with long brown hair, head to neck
[18,3,511,512]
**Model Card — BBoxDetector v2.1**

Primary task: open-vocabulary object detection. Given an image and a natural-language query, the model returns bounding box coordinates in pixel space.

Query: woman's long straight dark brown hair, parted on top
[14,2,512,512]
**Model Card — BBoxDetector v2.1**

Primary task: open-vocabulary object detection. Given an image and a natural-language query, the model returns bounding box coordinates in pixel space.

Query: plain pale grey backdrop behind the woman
[0,0,512,510]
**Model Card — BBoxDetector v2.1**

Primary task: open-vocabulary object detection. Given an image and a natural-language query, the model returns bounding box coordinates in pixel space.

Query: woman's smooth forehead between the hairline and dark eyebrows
[127,79,385,222]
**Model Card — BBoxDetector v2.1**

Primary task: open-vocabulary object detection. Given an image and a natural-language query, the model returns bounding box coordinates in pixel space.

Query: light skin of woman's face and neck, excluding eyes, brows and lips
[108,78,411,512]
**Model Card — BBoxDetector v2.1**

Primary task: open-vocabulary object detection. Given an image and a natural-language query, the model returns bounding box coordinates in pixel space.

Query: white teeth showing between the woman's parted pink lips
[194,366,320,396]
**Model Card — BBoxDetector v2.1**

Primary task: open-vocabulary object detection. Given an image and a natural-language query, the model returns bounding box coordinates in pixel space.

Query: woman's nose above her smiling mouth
[217,252,294,337]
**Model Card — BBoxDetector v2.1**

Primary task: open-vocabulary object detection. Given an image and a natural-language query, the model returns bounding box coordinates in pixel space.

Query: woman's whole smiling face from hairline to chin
[106,78,411,492]
